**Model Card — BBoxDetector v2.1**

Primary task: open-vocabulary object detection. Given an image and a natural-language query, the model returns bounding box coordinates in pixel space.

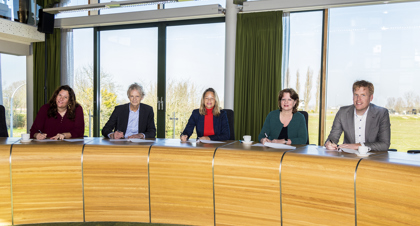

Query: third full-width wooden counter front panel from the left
[149,146,215,225]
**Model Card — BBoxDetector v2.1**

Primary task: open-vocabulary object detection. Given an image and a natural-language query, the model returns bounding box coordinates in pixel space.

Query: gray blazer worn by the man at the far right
[327,103,391,151]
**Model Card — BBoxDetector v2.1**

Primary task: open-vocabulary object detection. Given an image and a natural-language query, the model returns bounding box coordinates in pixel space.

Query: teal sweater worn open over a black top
[258,110,308,144]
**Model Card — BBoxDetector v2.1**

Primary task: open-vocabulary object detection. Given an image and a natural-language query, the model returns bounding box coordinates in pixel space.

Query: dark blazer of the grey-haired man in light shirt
[102,103,156,138]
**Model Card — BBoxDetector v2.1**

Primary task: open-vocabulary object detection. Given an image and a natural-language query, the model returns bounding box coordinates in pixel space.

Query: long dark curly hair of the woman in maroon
[47,85,79,121]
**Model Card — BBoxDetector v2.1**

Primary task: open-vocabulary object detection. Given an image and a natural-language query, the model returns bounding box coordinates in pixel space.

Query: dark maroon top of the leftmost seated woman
[31,104,85,138]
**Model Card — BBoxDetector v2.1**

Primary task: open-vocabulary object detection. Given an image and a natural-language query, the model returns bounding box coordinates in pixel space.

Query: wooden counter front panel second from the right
[281,152,359,225]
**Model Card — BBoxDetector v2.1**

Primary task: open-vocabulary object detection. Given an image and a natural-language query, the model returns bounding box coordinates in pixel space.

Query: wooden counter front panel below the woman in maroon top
[12,142,83,224]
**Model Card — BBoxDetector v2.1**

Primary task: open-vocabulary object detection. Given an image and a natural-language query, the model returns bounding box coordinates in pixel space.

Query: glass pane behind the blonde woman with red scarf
[166,23,225,138]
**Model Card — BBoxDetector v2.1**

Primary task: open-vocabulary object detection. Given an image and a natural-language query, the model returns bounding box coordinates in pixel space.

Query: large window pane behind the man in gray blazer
[326,2,420,151]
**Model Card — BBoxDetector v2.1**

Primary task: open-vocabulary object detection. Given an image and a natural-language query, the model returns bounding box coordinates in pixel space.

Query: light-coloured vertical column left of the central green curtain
[224,0,239,109]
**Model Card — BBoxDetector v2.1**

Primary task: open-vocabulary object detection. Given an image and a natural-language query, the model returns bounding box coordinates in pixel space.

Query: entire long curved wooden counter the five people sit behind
[0,138,420,225]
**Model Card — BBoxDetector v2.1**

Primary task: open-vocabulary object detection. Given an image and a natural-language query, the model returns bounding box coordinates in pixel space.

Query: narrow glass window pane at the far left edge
[0,54,27,137]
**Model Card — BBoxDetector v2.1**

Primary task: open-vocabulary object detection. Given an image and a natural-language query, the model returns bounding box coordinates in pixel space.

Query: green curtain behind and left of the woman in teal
[234,11,283,142]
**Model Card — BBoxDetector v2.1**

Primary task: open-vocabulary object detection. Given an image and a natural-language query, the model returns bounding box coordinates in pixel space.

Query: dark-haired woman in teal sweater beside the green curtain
[258,89,308,144]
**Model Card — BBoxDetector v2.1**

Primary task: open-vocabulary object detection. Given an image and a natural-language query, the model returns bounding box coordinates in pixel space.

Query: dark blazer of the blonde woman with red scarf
[182,109,230,140]
